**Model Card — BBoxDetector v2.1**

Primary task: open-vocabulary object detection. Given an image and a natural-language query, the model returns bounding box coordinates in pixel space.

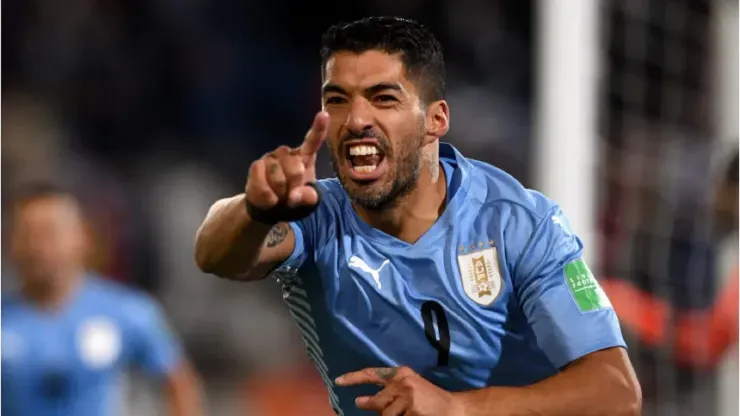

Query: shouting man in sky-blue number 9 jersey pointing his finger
[195,18,641,416]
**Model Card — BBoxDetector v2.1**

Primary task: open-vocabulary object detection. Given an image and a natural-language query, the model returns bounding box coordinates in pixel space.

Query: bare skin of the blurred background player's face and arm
[10,195,201,415]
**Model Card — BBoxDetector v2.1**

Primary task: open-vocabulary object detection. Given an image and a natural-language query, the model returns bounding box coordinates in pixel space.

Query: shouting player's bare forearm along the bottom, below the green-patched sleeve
[458,350,641,416]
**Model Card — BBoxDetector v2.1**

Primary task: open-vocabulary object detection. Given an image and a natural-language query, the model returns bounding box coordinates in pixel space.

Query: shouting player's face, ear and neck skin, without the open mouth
[322,50,450,242]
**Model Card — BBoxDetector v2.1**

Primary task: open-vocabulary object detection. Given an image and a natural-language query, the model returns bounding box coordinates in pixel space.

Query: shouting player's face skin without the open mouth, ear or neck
[322,52,425,211]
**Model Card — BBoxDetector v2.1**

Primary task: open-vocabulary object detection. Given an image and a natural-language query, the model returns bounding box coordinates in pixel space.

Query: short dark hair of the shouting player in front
[321,17,446,102]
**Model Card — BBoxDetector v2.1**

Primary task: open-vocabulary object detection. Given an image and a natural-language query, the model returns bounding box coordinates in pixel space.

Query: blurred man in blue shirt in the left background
[2,185,200,416]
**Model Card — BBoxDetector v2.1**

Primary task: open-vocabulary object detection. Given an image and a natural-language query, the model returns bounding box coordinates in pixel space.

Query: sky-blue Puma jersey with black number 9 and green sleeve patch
[276,143,625,415]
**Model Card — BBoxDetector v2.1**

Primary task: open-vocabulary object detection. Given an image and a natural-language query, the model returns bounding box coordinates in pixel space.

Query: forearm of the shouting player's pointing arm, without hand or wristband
[195,194,271,277]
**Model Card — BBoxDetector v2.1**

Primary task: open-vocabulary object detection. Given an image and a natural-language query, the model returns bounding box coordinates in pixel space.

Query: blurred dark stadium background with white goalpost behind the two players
[2,0,738,416]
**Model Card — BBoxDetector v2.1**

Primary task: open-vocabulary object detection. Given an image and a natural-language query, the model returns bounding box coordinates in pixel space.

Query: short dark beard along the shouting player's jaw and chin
[331,153,421,212]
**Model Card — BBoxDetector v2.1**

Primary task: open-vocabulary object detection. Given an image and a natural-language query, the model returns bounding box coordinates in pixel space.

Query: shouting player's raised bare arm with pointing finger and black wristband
[195,112,329,280]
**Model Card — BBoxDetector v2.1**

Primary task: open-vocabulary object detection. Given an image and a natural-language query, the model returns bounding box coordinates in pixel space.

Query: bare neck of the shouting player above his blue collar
[355,148,447,244]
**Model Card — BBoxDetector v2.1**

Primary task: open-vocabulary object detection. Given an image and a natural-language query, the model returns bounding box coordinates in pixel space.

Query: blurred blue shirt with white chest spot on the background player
[2,278,181,416]
